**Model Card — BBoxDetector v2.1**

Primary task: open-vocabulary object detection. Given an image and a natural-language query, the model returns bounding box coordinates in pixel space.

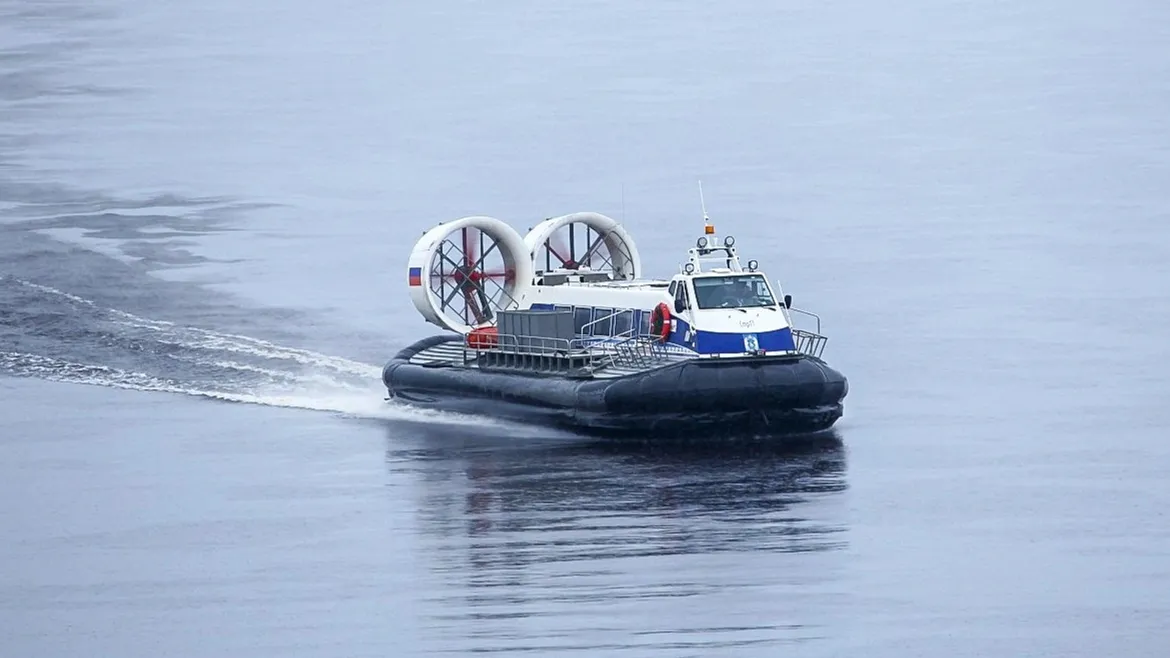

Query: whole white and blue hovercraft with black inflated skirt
[383,200,848,436]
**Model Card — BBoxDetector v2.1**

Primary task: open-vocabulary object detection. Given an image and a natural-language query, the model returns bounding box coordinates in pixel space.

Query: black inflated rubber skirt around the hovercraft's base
[381,336,849,438]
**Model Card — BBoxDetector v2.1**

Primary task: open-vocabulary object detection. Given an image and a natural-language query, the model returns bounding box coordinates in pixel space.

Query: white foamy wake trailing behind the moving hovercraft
[0,277,493,424]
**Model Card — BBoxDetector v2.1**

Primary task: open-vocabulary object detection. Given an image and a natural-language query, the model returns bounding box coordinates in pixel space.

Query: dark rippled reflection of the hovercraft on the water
[387,429,846,654]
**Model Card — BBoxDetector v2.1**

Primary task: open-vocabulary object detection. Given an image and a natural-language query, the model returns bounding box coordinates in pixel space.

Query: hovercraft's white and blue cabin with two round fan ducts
[408,196,824,357]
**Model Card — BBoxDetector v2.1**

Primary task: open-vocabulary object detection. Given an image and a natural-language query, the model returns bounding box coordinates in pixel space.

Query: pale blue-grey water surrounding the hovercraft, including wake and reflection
[0,0,1170,657]
